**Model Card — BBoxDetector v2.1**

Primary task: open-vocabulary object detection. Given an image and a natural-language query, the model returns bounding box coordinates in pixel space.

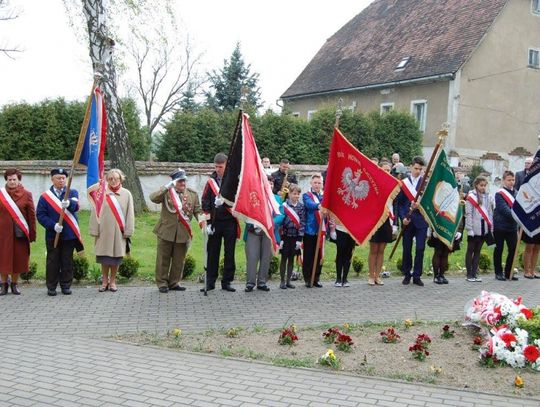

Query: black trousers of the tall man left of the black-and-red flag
[206,219,237,288]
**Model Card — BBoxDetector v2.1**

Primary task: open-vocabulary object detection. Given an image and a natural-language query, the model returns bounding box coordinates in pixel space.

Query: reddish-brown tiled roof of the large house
[282,0,508,98]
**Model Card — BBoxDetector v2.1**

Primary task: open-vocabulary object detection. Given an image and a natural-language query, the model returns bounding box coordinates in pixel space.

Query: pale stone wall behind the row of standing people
[0,161,326,211]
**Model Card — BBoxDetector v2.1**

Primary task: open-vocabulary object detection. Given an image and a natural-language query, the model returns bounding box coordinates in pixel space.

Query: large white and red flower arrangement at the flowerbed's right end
[465,291,540,371]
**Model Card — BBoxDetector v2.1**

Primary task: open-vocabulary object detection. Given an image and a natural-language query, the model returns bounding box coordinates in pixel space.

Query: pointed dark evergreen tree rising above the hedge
[206,43,262,111]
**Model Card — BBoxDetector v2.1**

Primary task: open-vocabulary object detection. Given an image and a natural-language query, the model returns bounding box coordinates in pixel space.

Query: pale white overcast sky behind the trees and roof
[0,0,371,107]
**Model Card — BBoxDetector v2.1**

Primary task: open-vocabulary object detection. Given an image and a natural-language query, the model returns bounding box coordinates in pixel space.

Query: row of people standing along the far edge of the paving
[0,153,540,296]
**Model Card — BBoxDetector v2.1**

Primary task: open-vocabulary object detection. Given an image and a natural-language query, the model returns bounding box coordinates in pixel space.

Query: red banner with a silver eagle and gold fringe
[322,128,400,244]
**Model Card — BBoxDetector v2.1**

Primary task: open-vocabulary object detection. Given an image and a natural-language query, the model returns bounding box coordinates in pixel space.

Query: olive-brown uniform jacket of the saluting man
[150,187,202,243]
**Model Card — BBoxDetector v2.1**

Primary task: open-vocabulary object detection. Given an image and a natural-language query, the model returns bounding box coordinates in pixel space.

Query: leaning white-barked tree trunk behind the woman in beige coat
[82,0,147,213]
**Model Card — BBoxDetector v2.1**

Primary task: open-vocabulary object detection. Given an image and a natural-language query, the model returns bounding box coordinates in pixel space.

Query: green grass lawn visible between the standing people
[31,211,510,281]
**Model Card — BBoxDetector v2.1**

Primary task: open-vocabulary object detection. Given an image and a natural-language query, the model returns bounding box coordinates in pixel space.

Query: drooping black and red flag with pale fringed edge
[220,112,279,253]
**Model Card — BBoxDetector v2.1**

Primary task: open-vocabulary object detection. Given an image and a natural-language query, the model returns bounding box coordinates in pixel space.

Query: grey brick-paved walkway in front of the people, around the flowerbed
[0,277,540,407]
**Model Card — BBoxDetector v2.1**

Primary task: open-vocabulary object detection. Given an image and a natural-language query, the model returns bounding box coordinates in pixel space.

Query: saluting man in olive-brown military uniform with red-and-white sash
[150,168,206,293]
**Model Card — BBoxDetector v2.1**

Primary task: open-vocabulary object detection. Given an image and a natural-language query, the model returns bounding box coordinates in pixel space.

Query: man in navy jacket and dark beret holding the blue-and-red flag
[36,168,82,297]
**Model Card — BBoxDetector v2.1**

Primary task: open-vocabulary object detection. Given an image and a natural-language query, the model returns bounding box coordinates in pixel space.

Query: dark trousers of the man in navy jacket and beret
[45,240,77,290]
